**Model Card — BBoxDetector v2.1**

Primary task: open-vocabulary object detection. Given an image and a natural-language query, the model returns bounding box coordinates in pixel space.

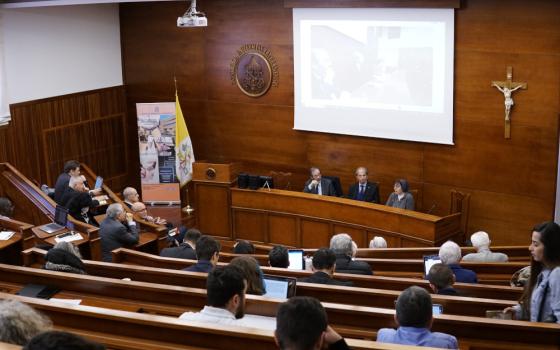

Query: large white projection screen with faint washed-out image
[294,9,454,144]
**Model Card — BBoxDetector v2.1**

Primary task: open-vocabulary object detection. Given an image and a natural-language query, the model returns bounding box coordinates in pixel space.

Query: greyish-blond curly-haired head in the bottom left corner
[0,300,52,345]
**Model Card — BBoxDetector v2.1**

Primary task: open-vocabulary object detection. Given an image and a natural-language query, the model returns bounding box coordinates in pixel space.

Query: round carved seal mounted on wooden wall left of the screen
[230,44,278,97]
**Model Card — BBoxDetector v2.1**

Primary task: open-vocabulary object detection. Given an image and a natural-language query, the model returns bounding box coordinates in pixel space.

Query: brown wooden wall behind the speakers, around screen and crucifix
[121,0,560,245]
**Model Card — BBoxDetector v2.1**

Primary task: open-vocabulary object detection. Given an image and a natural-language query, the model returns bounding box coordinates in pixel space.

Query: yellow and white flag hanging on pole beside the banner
[175,91,194,187]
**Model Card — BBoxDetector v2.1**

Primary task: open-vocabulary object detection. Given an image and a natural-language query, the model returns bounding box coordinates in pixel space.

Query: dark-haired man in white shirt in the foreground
[179,265,276,330]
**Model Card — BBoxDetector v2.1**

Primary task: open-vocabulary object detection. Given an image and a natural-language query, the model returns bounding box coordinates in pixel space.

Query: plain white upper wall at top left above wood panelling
[2,4,123,104]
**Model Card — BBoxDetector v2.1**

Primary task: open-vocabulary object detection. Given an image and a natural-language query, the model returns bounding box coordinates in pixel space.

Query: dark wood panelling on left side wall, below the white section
[0,86,131,191]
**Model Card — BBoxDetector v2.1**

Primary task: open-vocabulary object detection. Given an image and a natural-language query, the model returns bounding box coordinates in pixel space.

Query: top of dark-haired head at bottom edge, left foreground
[23,331,105,350]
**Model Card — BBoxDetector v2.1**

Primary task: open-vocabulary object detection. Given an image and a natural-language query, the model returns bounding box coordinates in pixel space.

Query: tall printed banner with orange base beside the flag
[136,102,181,204]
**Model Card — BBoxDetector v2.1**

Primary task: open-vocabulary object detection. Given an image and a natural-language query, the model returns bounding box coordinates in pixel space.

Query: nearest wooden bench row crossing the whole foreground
[0,265,560,349]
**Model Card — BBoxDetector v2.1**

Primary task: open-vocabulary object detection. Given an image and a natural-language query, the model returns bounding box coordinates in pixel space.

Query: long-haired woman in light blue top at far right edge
[504,221,560,323]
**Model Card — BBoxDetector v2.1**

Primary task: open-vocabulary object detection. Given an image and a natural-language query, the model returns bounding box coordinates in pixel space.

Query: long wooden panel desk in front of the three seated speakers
[230,188,460,248]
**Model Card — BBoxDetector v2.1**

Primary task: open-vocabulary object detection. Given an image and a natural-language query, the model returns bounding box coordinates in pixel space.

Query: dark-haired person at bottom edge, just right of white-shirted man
[274,297,350,350]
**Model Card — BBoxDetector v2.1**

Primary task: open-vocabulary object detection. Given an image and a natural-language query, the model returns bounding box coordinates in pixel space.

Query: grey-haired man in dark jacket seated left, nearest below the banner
[99,203,140,262]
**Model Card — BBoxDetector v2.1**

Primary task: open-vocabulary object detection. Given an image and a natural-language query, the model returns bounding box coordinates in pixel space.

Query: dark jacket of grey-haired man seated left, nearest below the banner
[99,217,140,262]
